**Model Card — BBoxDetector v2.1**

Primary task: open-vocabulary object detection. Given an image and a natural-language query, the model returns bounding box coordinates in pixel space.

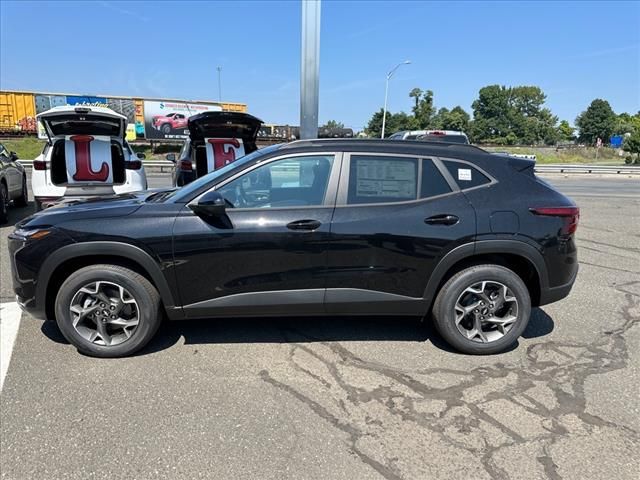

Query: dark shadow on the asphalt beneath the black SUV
[41,308,554,355]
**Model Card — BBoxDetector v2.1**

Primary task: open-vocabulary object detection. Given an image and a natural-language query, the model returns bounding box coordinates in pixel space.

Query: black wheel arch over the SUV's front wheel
[36,242,176,318]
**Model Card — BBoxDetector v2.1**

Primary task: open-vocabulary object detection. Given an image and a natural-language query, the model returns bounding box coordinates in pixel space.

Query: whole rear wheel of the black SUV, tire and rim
[433,265,531,355]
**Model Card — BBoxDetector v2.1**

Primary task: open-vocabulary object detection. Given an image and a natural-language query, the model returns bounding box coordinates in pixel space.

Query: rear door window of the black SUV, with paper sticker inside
[347,155,418,205]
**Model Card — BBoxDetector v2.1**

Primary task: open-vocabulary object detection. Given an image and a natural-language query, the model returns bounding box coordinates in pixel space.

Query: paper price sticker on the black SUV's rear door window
[356,159,416,199]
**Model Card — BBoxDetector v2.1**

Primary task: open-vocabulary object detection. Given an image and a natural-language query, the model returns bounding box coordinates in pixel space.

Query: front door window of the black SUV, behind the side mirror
[219,155,333,208]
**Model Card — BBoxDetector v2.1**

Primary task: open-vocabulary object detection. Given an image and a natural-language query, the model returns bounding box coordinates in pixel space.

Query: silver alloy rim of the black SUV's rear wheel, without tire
[454,281,518,343]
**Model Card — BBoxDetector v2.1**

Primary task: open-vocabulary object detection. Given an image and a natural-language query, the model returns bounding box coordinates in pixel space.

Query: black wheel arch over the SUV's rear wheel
[424,240,548,310]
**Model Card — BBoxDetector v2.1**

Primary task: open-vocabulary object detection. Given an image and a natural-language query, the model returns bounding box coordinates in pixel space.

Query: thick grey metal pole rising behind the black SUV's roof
[300,0,320,138]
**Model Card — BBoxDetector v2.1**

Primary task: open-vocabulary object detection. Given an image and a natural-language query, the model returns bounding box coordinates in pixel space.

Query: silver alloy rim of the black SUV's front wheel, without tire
[69,281,140,346]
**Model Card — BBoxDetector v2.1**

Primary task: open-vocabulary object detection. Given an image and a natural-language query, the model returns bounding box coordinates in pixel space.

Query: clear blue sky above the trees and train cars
[0,0,640,130]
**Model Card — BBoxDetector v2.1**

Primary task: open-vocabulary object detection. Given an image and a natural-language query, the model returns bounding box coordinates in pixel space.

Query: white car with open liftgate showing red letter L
[31,106,147,210]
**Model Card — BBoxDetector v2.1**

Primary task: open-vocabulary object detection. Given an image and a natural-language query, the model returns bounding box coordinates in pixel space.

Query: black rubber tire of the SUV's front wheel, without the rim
[55,265,163,358]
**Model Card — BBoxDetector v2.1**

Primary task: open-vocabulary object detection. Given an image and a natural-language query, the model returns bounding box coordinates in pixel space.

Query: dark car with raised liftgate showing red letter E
[167,112,263,186]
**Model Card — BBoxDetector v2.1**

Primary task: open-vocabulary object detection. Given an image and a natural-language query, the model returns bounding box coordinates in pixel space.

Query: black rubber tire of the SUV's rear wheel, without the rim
[432,265,531,355]
